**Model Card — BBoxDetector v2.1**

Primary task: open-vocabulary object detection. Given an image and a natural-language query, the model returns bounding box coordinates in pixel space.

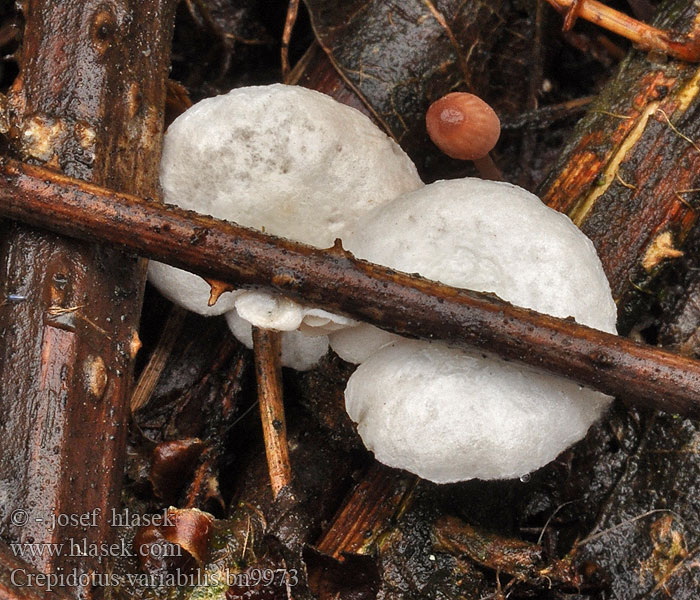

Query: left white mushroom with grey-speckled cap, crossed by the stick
[149,84,422,368]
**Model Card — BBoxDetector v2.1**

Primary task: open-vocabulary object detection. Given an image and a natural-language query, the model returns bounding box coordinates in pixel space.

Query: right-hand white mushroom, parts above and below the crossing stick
[331,179,616,483]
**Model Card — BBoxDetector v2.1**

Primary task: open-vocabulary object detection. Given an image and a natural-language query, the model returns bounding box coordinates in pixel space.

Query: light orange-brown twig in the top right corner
[547,0,700,62]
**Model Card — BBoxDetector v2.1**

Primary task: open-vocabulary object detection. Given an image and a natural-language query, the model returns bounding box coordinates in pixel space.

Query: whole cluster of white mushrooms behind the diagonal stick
[149,85,616,483]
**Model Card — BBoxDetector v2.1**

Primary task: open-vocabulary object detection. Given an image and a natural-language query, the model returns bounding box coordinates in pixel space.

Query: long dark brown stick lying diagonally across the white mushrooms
[0,160,700,416]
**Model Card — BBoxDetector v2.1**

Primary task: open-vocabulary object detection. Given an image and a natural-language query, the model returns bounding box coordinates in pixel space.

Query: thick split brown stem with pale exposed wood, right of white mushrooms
[540,0,700,324]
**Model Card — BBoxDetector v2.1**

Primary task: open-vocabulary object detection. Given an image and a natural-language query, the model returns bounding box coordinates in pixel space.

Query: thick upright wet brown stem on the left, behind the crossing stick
[0,0,175,593]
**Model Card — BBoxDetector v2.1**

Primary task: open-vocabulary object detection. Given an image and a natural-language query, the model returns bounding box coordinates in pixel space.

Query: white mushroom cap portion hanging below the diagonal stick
[345,341,610,483]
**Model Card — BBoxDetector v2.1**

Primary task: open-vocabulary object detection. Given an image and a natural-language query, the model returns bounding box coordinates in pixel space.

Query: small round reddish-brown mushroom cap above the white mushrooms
[425,92,501,160]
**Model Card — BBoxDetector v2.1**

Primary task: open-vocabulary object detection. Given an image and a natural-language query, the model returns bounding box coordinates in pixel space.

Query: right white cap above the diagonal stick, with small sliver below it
[330,177,617,362]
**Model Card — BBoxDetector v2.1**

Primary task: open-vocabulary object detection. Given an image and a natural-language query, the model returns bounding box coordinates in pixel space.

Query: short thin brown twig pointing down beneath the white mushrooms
[253,327,292,498]
